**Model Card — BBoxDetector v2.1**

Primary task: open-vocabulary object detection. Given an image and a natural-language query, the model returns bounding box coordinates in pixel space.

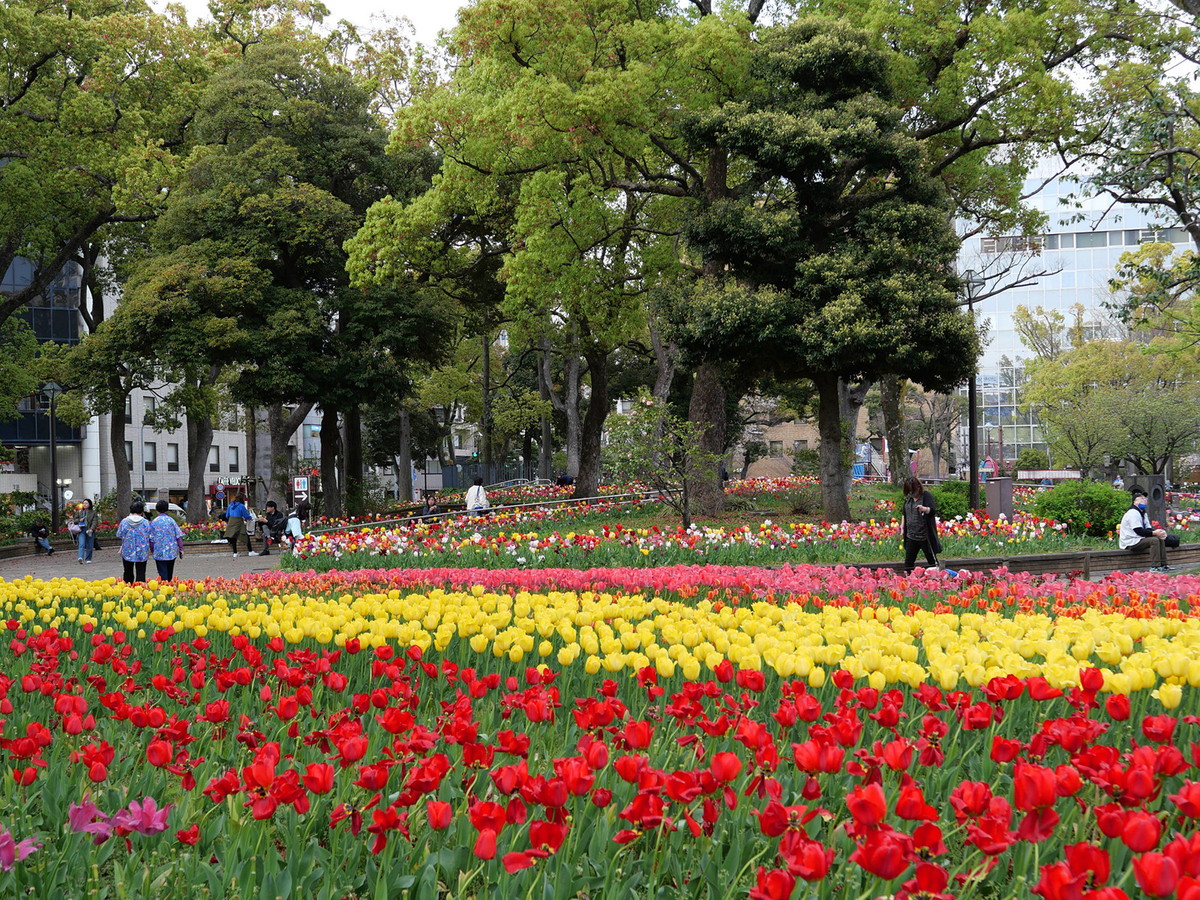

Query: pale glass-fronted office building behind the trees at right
[958,173,1190,464]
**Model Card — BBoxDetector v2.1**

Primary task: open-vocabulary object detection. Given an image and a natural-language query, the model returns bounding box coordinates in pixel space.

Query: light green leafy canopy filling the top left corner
[0,0,202,331]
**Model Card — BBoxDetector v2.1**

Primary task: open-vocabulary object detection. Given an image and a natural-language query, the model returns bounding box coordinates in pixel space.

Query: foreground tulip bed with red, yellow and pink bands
[0,566,1200,900]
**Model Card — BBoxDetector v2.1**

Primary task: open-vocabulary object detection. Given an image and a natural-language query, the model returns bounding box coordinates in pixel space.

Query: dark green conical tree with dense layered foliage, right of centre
[676,19,978,521]
